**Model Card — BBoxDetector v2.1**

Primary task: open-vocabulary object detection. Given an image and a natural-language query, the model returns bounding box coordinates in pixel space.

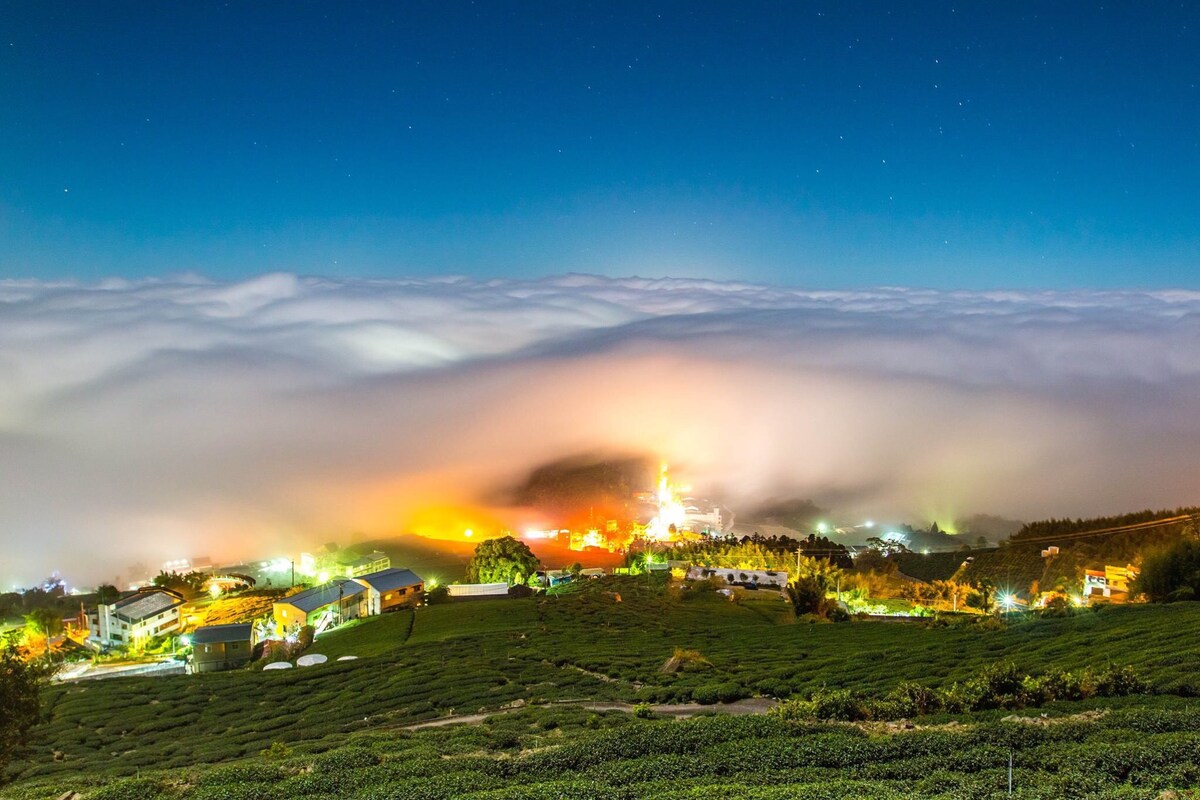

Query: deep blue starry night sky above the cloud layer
[0,0,1200,288]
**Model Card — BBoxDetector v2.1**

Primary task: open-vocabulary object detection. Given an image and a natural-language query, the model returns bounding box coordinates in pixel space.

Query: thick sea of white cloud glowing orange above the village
[0,275,1200,583]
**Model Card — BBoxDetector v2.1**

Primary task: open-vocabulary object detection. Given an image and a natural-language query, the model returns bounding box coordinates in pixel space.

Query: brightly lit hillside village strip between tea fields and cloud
[2,464,1174,681]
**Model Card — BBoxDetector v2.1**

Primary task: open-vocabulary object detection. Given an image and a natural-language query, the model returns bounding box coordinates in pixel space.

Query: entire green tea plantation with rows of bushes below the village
[7,578,1200,800]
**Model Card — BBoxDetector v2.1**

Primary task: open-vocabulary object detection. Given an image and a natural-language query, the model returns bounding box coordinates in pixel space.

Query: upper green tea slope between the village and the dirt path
[7,579,1200,796]
